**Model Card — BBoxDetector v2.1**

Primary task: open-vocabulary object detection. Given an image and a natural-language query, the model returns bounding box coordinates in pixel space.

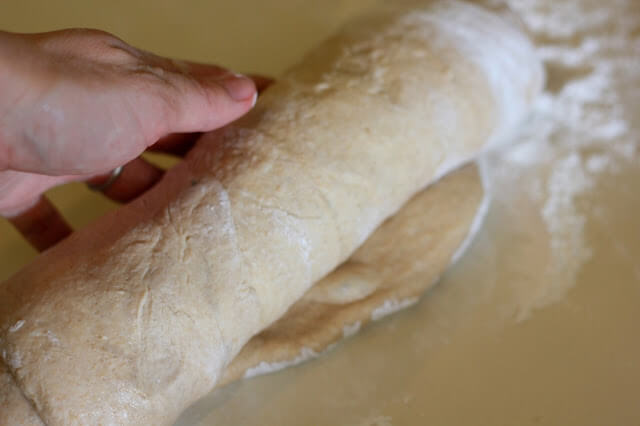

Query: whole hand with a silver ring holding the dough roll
[0,30,269,250]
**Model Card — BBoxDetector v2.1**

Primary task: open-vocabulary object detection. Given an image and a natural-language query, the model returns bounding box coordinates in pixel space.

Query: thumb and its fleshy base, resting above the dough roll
[0,30,267,176]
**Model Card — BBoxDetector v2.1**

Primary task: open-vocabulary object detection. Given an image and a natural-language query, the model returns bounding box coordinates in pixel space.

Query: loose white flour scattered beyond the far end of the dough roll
[482,0,640,319]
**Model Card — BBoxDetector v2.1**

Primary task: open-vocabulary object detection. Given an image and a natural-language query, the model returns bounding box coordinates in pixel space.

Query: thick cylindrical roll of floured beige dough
[0,1,542,425]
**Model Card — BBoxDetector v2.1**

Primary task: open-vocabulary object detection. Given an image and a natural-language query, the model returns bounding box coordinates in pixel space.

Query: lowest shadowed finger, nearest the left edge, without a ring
[9,196,72,251]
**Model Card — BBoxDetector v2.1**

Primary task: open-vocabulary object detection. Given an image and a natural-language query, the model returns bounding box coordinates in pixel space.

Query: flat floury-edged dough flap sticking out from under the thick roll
[218,161,488,386]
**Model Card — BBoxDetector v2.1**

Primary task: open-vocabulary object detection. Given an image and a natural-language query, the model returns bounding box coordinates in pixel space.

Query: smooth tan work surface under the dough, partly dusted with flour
[0,0,640,426]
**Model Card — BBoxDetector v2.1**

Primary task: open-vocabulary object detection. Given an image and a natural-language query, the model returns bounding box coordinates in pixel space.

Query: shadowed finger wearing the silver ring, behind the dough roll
[87,158,164,203]
